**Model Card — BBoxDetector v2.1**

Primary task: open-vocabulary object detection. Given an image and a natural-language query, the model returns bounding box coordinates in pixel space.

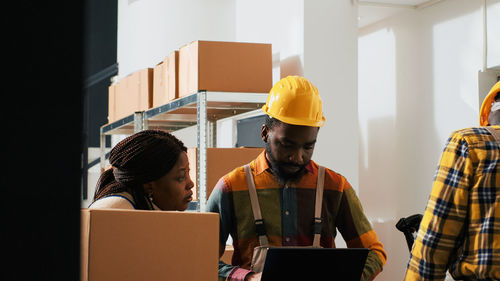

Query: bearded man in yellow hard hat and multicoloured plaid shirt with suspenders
[207,76,387,280]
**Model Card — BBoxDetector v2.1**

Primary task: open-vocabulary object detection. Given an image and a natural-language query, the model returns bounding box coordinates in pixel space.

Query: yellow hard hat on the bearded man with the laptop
[262,76,325,127]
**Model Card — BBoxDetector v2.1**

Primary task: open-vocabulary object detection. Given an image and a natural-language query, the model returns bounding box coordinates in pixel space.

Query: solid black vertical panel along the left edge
[0,0,84,281]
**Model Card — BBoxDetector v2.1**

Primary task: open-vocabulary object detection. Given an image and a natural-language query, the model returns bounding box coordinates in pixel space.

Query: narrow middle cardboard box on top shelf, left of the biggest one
[153,50,179,107]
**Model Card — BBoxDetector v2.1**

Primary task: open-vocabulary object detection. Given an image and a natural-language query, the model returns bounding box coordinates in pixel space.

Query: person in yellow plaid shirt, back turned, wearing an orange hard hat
[405,82,500,281]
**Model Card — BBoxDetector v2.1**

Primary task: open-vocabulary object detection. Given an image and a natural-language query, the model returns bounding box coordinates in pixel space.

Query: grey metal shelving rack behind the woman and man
[100,91,267,212]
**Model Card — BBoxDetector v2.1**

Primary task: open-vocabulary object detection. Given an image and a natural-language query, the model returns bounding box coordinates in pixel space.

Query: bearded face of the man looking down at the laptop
[261,120,319,184]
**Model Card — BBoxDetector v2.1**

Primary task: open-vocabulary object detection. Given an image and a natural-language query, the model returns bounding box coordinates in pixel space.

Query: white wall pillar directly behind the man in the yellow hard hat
[304,1,359,191]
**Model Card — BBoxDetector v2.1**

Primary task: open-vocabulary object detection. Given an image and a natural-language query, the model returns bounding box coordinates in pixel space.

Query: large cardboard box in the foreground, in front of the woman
[81,209,219,281]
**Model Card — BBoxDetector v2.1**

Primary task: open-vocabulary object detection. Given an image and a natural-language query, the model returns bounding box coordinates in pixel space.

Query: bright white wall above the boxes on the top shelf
[117,0,235,77]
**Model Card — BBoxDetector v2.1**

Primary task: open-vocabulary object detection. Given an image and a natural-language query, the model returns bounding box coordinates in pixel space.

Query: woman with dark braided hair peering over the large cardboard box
[89,130,194,211]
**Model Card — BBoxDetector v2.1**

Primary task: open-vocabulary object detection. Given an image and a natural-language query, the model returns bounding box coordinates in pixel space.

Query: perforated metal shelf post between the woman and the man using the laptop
[196,91,208,212]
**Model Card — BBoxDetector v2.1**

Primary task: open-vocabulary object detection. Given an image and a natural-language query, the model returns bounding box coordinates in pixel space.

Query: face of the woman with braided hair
[146,152,194,211]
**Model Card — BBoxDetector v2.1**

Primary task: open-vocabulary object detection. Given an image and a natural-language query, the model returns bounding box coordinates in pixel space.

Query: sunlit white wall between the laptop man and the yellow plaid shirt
[358,0,500,280]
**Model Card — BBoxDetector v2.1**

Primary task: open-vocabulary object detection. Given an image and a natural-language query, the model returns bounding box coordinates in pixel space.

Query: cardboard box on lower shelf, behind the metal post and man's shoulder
[187,147,264,199]
